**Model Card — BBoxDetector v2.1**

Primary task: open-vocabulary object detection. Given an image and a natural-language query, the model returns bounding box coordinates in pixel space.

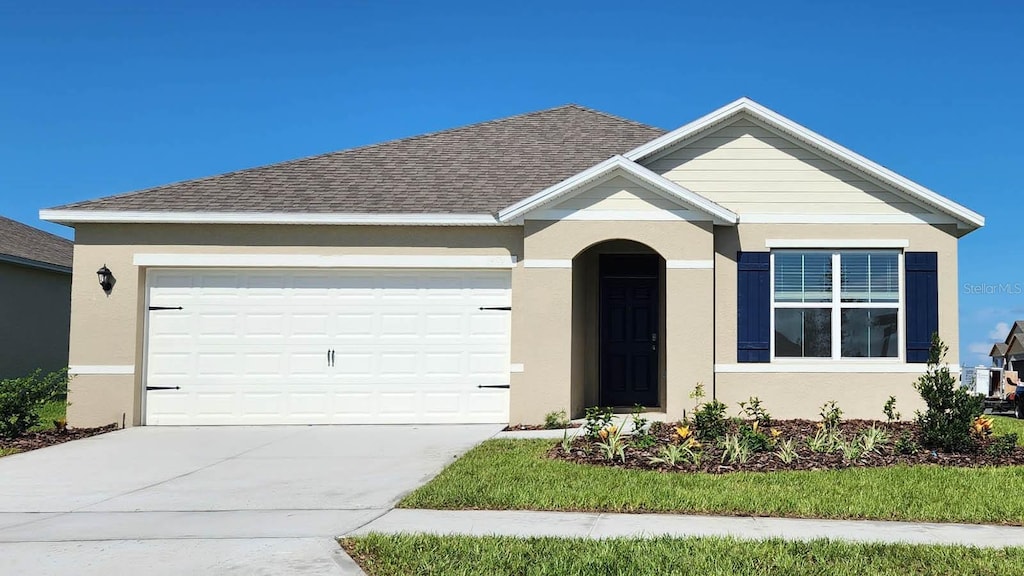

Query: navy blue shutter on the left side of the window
[736,252,771,362]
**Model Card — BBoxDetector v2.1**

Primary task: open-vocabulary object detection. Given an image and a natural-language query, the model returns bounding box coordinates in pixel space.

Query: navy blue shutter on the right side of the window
[903,252,939,363]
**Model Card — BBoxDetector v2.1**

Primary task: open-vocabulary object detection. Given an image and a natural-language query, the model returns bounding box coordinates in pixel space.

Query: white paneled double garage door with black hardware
[145,270,511,424]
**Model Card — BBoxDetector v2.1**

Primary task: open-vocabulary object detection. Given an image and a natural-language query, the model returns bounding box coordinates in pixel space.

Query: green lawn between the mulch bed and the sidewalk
[398,440,1024,525]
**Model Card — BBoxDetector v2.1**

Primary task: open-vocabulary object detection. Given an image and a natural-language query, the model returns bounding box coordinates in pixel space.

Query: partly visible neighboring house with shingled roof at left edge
[0,216,74,379]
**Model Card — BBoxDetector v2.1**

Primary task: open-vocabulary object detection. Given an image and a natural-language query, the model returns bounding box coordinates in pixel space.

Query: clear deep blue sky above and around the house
[0,0,1024,363]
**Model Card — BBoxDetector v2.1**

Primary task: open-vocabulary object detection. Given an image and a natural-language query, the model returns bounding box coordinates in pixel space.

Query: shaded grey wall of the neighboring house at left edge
[0,262,71,378]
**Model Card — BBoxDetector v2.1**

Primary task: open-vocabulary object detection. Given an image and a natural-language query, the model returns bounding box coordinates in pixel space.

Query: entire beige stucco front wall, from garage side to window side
[69,220,958,426]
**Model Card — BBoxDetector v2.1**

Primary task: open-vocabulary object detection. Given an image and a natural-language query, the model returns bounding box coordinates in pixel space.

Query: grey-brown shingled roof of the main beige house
[56,105,665,214]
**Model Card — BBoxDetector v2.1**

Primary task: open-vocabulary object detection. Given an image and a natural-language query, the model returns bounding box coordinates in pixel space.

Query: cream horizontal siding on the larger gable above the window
[642,119,929,215]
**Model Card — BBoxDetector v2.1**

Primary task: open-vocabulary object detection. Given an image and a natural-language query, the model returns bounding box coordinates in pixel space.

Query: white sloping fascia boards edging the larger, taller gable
[624,97,985,230]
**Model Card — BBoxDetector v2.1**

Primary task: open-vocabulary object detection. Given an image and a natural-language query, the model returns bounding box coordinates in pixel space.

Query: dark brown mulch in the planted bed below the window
[548,420,1024,474]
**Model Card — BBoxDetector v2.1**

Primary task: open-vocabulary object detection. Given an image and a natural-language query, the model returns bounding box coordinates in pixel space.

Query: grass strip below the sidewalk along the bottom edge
[341,534,1024,576]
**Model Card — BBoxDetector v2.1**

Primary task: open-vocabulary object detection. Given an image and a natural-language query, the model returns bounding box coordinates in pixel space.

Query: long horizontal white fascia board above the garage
[39,209,504,225]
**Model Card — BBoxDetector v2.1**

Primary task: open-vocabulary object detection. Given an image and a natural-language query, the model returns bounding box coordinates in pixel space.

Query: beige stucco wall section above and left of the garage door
[68,220,522,426]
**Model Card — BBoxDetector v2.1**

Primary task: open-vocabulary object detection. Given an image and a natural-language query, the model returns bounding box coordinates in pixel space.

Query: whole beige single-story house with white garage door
[41,98,984,425]
